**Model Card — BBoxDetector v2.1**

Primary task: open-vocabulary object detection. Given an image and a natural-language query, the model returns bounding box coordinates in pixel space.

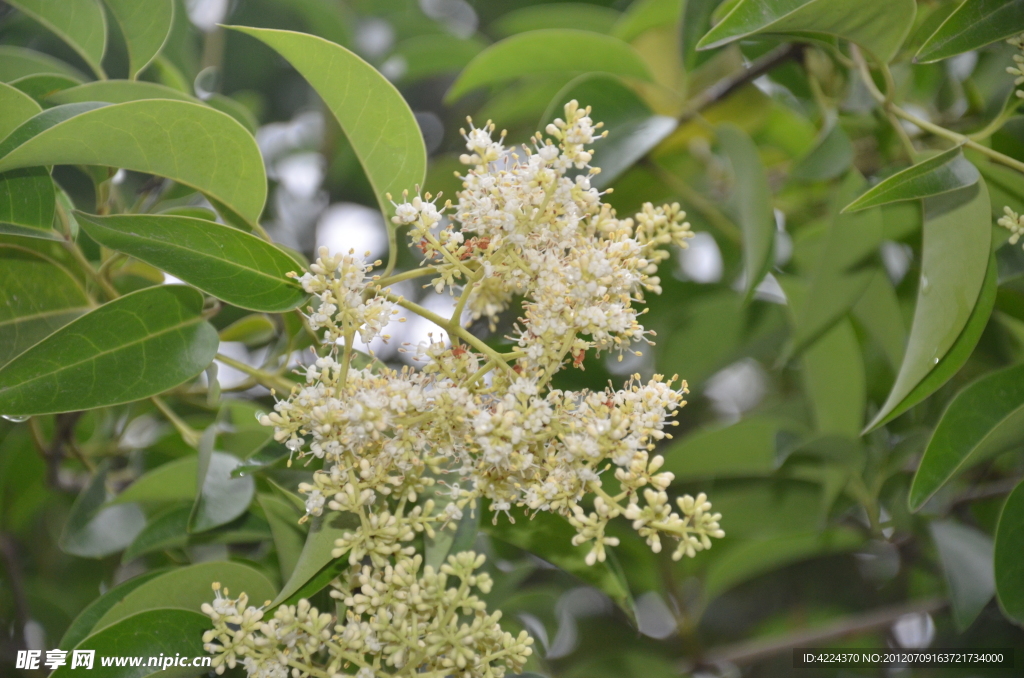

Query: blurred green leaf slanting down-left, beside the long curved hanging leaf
[790,172,883,355]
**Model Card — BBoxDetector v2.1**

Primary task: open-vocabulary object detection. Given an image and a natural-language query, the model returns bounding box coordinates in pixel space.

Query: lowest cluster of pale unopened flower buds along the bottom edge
[203,551,534,678]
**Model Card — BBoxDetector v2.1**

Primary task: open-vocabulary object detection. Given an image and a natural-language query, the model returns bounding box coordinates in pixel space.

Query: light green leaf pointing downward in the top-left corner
[7,0,106,78]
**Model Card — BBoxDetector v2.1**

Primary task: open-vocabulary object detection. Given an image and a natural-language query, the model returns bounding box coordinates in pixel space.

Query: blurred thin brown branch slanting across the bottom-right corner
[686,598,949,671]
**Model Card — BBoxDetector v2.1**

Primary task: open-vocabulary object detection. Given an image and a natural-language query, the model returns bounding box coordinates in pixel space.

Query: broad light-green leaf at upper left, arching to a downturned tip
[0,99,266,224]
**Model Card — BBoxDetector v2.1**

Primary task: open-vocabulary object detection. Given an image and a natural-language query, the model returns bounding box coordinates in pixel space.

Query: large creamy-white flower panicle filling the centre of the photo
[215,101,724,678]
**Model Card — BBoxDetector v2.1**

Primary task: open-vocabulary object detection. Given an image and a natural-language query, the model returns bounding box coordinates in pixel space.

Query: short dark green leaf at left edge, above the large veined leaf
[0,246,90,367]
